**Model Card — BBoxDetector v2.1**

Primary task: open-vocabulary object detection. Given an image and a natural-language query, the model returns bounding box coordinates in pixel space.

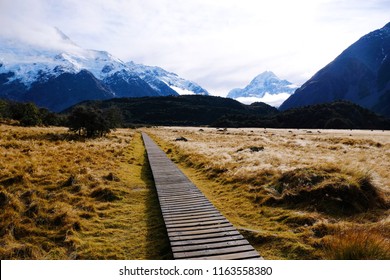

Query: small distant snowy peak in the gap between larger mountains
[227,71,298,107]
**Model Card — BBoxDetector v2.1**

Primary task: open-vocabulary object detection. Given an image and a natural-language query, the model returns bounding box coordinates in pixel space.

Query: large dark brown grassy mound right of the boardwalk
[264,168,386,215]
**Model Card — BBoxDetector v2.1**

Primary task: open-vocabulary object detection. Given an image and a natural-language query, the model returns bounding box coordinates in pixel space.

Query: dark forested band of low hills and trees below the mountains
[0,95,390,131]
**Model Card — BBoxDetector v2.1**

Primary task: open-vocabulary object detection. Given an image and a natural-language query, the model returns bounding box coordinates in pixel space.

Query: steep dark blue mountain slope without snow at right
[279,23,390,117]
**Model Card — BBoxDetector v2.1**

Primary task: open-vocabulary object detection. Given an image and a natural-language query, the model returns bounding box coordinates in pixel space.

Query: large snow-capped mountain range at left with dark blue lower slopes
[0,29,208,111]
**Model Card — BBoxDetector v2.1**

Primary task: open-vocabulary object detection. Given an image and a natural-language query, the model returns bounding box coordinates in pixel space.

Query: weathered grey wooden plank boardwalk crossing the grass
[142,133,262,260]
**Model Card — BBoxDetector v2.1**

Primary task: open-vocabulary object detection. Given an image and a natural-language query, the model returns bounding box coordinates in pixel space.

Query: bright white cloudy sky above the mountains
[0,0,390,96]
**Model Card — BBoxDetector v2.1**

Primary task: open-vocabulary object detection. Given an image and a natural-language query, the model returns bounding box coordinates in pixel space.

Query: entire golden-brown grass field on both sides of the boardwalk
[0,125,390,259]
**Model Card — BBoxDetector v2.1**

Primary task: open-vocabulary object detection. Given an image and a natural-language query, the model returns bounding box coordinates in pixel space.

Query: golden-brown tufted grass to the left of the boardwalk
[0,125,171,259]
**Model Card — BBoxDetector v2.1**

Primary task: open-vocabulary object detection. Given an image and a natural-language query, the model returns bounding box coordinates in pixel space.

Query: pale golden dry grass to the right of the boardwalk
[147,127,390,259]
